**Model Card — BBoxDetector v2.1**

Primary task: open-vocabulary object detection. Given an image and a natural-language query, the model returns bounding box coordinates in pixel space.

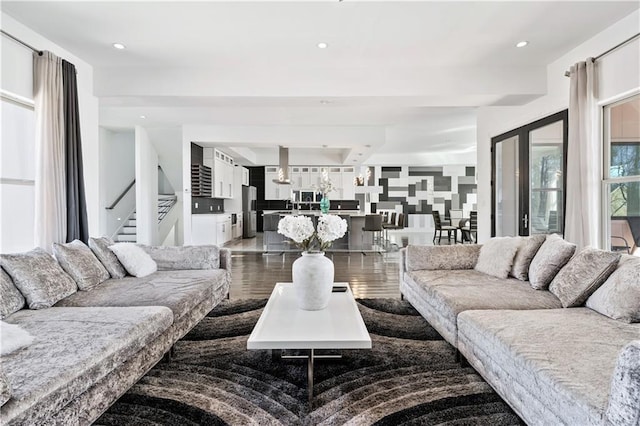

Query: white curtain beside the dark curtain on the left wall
[33,52,67,252]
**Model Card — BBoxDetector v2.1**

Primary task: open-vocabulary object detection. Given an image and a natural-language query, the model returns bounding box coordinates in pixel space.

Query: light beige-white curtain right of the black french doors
[565,58,601,249]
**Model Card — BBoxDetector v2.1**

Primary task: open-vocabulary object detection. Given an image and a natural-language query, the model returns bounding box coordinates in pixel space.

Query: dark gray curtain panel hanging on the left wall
[62,60,89,243]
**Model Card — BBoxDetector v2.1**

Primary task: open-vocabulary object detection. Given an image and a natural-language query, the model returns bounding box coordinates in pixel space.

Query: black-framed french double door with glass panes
[491,110,568,237]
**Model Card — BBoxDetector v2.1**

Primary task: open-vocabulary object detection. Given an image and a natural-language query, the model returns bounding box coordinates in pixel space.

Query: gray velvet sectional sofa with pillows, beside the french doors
[400,237,640,426]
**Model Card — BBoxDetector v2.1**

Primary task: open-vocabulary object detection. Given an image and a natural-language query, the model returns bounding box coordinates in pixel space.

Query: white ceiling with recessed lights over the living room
[0,0,639,164]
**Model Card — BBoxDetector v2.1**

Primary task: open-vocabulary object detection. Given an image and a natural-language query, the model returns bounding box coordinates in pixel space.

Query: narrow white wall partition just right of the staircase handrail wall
[135,126,160,245]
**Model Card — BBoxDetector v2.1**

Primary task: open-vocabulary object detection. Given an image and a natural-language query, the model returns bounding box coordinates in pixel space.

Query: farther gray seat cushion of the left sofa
[56,269,227,321]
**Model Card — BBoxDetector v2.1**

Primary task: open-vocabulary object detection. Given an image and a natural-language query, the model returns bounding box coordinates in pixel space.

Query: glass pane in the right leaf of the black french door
[525,121,564,234]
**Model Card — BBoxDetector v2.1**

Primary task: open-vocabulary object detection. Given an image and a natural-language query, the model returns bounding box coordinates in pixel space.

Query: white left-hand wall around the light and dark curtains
[1,13,100,238]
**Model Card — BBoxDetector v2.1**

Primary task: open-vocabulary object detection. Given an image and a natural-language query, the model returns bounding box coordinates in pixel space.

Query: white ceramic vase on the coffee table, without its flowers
[291,251,334,311]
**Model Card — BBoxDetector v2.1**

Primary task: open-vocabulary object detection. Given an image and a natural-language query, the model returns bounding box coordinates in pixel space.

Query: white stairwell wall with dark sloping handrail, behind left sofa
[100,128,136,237]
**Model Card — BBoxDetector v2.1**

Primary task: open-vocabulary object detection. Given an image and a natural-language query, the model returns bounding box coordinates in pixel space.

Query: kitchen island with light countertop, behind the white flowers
[263,210,373,253]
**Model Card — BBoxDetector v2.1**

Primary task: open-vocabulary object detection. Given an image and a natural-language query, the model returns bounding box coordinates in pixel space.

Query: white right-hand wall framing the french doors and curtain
[477,11,640,242]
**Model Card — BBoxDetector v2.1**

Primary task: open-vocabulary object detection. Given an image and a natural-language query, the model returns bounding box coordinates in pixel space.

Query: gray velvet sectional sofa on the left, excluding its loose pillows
[0,239,231,425]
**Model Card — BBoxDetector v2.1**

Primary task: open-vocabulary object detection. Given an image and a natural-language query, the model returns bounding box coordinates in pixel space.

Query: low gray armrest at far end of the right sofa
[406,244,482,271]
